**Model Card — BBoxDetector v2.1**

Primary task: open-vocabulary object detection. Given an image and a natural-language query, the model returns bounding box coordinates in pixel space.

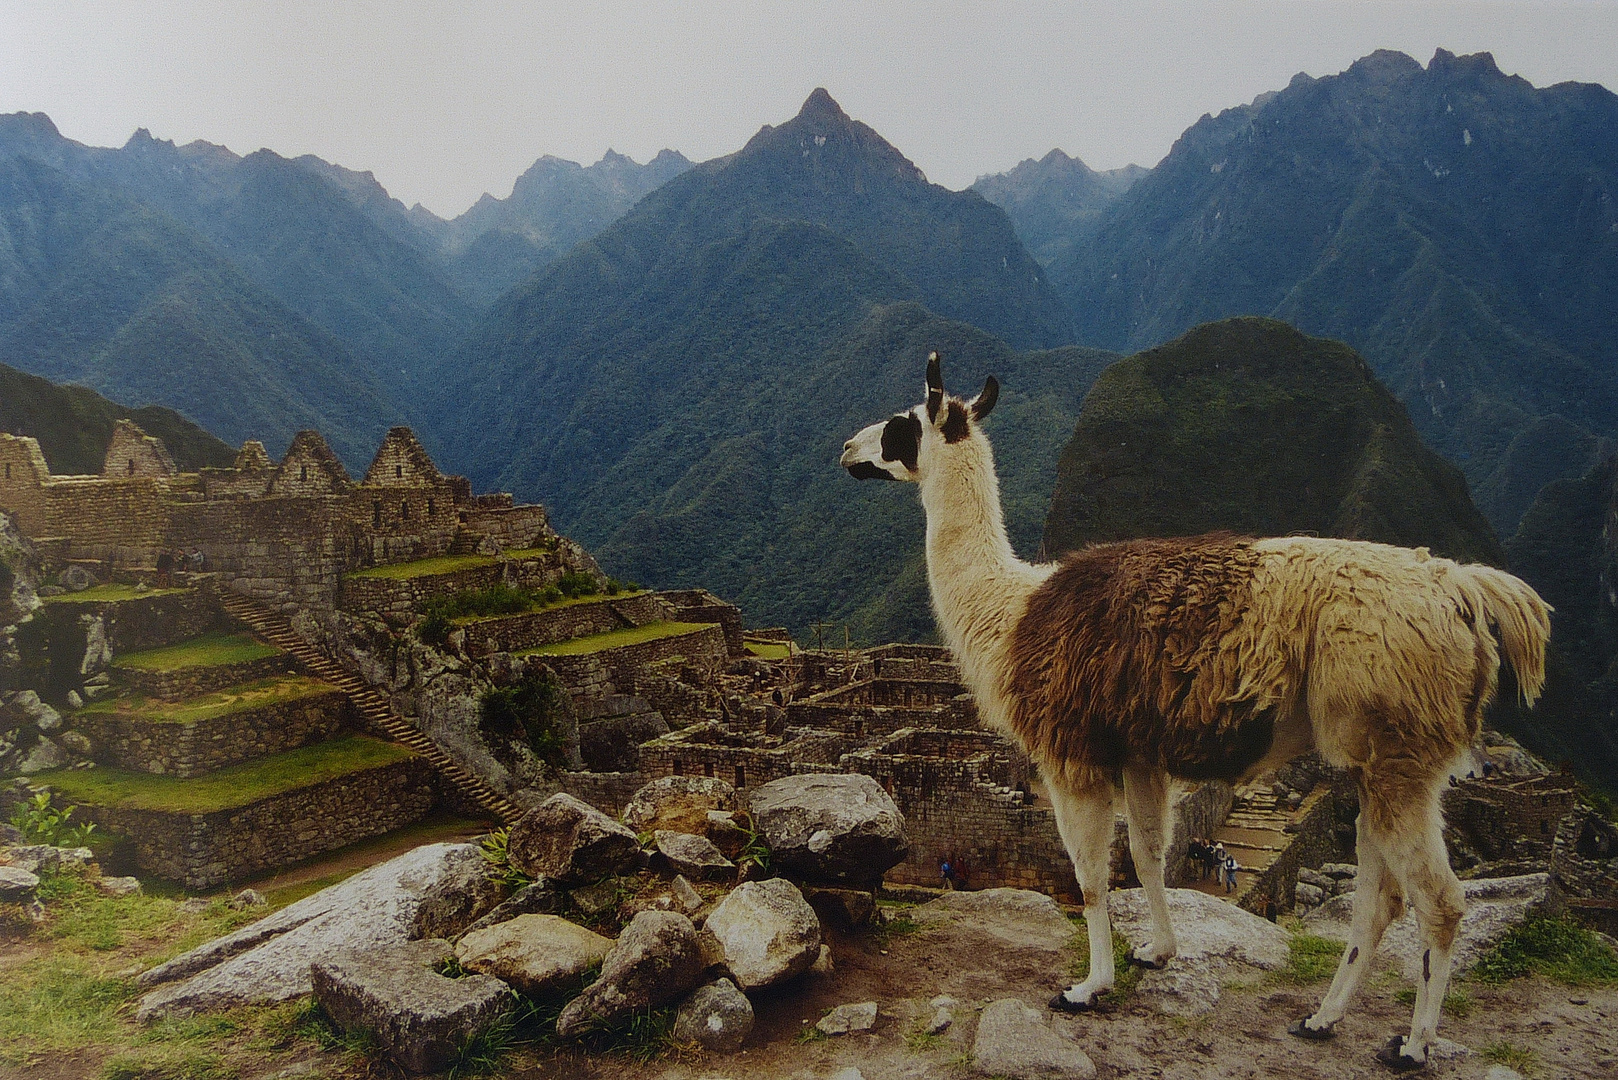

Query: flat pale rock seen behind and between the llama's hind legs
[1304,874,1565,983]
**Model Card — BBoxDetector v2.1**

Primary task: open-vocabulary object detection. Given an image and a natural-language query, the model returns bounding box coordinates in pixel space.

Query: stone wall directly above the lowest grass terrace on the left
[68,688,353,779]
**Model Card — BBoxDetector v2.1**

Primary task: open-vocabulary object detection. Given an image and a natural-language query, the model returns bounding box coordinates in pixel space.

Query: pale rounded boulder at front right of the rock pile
[704,878,820,991]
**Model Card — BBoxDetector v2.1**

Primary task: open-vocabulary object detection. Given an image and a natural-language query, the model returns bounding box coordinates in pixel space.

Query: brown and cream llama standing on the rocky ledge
[840,353,1550,1072]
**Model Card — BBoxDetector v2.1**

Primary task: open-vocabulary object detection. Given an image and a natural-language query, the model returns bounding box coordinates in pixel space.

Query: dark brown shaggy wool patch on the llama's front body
[1006,534,1277,779]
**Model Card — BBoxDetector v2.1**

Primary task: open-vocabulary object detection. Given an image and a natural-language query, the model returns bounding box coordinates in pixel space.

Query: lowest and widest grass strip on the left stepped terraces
[37,735,411,814]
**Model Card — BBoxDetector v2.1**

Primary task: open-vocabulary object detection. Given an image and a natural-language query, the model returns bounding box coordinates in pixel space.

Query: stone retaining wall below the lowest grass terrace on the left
[83,758,434,889]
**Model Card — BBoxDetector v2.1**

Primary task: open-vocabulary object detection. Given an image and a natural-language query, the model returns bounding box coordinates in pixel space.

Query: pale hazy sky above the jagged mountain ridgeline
[0,0,1618,217]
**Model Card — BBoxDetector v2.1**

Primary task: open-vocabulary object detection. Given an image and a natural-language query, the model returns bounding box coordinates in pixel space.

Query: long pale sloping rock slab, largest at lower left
[136,844,500,1020]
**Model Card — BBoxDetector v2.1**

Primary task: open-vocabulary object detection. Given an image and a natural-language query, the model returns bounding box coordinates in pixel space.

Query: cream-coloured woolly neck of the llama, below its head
[921,432,1052,722]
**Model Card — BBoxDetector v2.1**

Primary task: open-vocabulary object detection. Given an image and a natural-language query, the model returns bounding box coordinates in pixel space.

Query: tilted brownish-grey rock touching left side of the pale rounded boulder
[557,912,705,1038]
